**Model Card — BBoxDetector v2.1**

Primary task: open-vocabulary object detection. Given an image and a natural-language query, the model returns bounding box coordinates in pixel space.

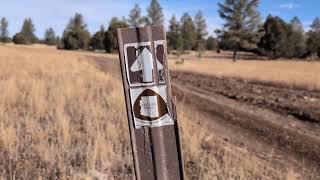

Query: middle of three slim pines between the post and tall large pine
[181,13,197,50]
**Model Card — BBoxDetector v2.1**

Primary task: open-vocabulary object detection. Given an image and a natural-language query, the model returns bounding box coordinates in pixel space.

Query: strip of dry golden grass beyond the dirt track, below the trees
[170,52,320,90]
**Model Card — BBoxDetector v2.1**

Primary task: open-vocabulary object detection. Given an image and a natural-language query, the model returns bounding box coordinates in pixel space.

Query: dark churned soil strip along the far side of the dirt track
[172,72,320,124]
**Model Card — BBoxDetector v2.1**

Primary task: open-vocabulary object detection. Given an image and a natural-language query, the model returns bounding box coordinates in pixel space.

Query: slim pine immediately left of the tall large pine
[194,11,208,56]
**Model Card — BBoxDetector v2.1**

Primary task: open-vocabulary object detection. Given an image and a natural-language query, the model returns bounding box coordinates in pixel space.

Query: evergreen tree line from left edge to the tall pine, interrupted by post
[1,0,218,52]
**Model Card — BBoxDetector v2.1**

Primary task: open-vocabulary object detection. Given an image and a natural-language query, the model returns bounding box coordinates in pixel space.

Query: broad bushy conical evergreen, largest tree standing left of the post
[59,13,90,50]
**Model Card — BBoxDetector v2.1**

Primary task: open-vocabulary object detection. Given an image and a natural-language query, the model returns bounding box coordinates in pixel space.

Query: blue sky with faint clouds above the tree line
[0,0,320,37]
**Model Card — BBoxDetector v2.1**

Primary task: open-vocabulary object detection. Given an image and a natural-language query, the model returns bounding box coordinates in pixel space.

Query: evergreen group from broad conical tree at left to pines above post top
[58,0,164,52]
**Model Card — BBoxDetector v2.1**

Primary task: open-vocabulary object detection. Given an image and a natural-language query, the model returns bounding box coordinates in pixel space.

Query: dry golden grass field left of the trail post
[0,46,132,179]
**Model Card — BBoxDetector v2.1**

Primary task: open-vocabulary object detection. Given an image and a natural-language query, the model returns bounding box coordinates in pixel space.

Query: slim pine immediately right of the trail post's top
[167,15,182,51]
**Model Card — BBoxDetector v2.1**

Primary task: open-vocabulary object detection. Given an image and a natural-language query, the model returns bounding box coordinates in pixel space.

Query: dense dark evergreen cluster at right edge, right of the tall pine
[258,15,320,58]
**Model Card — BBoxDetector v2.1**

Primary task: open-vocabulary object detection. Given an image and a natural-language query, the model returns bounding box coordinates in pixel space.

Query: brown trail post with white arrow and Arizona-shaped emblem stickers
[117,26,184,180]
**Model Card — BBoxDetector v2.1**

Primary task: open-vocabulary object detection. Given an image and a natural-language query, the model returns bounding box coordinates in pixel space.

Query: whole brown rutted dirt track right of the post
[171,72,320,177]
